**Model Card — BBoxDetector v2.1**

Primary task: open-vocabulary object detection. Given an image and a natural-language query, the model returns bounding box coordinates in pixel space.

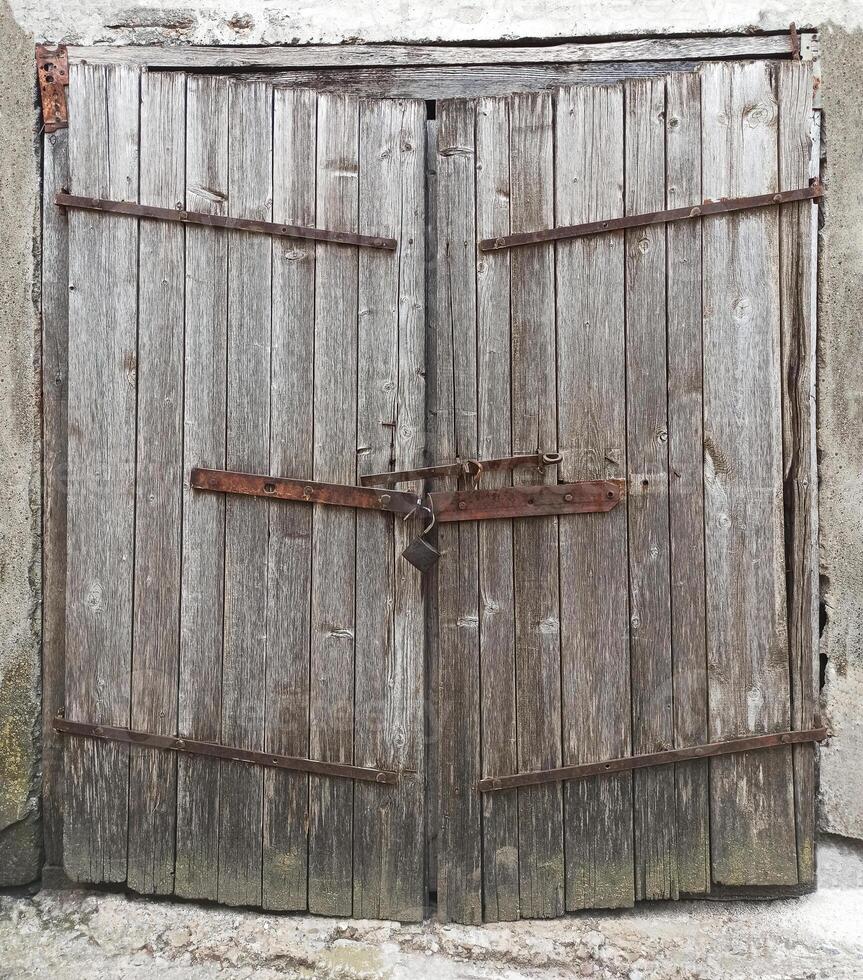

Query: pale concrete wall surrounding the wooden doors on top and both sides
[0,0,863,884]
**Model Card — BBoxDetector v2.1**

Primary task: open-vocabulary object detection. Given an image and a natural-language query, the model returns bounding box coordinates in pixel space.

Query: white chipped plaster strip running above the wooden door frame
[5,0,863,44]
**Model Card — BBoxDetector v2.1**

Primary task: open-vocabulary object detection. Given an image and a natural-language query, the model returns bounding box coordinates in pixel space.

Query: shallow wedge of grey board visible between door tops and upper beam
[248,61,698,100]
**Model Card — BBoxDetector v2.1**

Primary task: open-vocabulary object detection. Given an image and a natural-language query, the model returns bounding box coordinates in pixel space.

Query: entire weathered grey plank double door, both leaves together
[60,62,814,922]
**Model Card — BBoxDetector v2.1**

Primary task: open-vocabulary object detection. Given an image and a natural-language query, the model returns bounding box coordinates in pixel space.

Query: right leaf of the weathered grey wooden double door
[430,63,814,922]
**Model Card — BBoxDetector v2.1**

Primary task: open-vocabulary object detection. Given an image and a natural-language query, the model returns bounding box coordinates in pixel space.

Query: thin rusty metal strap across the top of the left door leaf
[54,194,398,251]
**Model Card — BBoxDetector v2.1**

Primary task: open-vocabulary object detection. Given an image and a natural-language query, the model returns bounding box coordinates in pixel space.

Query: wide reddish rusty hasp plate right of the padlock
[436,480,626,523]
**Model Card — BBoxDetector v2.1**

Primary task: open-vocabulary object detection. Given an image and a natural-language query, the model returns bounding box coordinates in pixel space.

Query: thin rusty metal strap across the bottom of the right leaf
[478,726,830,793]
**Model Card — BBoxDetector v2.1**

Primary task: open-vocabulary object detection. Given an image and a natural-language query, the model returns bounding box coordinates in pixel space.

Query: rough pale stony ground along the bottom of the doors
[0,842,863,980]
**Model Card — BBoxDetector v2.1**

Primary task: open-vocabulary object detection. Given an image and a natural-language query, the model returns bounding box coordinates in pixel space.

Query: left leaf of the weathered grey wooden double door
[60,66,425,919]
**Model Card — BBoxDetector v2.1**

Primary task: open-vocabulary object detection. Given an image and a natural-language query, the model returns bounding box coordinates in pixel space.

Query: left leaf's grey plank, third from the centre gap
[262,89,317,910]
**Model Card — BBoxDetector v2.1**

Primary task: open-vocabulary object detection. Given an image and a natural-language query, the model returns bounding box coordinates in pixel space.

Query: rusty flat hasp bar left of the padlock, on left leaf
[189,467,418,514]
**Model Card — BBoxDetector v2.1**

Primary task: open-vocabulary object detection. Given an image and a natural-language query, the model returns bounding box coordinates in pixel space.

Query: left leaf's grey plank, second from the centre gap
[309,95,359,915]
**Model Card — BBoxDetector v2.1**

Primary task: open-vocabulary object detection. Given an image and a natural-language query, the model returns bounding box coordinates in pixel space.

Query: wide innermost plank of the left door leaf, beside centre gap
[353,100,425,921]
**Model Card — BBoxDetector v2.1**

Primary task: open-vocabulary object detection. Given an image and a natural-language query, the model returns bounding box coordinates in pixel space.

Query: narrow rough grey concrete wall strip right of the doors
[818,23,863,838]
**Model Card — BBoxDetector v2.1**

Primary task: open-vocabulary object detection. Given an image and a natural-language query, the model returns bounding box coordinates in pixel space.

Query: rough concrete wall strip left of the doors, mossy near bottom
[0,0,41,885]
